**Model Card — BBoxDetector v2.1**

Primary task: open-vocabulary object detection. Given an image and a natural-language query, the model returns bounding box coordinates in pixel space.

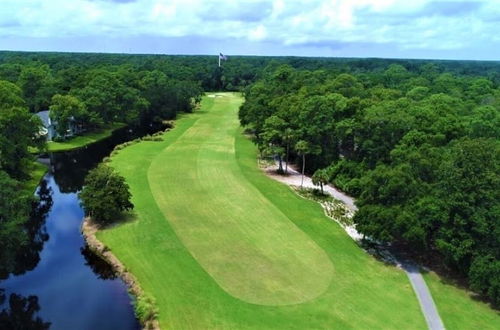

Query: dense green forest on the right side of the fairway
[239,60,500,305]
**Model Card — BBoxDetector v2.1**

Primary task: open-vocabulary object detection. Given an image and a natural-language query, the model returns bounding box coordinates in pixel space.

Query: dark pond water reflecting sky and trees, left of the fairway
[0,126,166,330]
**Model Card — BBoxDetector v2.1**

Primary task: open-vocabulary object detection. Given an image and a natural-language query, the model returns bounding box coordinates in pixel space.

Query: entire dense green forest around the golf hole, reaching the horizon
[0,52,500,304]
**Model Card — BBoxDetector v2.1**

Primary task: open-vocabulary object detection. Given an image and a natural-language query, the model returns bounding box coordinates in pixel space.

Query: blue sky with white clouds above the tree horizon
[0,0,500,60]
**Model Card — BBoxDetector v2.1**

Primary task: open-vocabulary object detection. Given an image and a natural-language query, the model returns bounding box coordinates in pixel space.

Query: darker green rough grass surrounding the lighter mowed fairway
[98,91,425,329]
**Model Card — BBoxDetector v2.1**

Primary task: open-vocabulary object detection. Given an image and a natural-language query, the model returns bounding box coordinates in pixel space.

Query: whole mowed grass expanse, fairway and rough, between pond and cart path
[98,94,426,329]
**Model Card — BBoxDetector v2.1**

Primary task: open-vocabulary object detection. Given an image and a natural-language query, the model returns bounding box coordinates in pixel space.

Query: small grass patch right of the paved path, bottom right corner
[424,273,500,330]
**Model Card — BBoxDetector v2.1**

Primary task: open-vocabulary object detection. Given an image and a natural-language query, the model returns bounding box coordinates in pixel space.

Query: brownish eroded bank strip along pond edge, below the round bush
[81,218,160,330]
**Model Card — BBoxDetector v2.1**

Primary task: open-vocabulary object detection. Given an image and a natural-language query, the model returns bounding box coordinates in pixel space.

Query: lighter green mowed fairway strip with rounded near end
[148,93,333,305]
